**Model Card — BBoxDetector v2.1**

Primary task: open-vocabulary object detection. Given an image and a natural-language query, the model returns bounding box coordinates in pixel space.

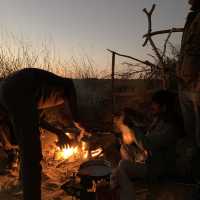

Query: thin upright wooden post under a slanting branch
[111,52,115,127]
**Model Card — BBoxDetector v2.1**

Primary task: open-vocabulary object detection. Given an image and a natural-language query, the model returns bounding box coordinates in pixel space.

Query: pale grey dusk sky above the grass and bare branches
[0,0,189,69]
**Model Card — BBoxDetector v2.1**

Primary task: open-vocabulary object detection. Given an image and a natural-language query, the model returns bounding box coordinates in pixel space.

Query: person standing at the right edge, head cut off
[177,0,200,179]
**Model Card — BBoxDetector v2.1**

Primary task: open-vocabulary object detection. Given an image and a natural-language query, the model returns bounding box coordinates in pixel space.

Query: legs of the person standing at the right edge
[177,85,200,177]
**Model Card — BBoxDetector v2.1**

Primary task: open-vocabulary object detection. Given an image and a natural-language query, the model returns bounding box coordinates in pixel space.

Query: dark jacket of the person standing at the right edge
[178,11,200,85]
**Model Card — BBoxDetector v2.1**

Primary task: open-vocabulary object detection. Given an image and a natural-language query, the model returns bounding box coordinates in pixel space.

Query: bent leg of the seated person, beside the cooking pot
[111,160,147,200]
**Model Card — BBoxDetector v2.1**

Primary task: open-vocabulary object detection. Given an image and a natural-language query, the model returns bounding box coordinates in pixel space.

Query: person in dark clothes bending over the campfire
[0,68,83,200]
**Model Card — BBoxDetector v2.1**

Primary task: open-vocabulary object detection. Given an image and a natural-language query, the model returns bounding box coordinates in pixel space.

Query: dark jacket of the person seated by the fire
[143,118,180,176]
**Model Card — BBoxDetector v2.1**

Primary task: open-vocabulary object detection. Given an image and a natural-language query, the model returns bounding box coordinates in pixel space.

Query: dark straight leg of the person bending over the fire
[12,107,42,200]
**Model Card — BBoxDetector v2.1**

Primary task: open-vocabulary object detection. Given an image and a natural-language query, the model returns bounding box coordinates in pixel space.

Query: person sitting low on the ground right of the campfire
[111,90,183,200]
